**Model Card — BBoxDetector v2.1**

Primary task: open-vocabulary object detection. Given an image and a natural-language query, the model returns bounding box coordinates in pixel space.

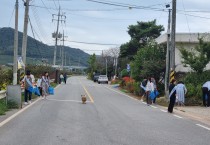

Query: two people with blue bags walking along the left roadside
[21,70,50,105]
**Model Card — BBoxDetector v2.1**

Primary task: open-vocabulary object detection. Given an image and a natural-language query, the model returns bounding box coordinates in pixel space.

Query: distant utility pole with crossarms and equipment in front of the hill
[52,6,66,65]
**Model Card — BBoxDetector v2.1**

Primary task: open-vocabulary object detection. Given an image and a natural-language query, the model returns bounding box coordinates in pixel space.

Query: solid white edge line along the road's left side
[0,85,60,127]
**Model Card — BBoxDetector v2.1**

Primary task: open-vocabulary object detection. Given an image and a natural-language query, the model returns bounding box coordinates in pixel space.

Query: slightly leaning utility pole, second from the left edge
[22,0,29,72]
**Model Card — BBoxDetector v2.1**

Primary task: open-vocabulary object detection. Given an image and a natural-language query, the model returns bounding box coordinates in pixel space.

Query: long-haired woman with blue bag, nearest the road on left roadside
[41,72,50,99]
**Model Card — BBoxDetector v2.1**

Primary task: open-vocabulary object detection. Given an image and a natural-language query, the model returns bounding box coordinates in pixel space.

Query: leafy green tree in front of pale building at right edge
[180,38,210,73]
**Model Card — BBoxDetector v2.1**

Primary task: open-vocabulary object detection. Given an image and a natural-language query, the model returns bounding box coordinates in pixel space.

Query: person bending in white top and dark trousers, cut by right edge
[202,81,210,107]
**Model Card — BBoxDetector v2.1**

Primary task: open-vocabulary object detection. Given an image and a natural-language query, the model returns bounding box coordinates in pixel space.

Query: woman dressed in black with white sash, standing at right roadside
[168,79,176,113]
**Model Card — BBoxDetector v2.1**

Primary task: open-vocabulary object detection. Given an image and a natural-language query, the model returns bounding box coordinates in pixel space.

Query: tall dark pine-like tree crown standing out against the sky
[120,20,164,60]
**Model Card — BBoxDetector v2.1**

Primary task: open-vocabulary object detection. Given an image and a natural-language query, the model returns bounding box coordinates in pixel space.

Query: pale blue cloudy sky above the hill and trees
[0,0,210,54]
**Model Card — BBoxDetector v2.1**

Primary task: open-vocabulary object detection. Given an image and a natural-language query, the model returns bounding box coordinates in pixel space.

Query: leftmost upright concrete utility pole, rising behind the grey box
[13,0,18,85]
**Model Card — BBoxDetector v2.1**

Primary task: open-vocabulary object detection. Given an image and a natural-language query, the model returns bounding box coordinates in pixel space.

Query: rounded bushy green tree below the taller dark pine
[131,41,166,81]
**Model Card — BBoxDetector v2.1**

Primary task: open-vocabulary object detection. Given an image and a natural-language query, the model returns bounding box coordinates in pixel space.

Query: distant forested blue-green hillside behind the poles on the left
[0,28,89,66]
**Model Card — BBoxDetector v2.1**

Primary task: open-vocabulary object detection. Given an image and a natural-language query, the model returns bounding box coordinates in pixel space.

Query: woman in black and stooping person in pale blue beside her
[168,79,187,113]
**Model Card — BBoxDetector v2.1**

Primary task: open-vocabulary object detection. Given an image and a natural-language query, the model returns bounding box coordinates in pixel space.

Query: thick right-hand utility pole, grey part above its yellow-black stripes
[170,0,176,71]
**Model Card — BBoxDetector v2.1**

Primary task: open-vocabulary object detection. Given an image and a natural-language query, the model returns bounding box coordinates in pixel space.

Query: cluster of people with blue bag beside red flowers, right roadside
[141,77,158,105]
